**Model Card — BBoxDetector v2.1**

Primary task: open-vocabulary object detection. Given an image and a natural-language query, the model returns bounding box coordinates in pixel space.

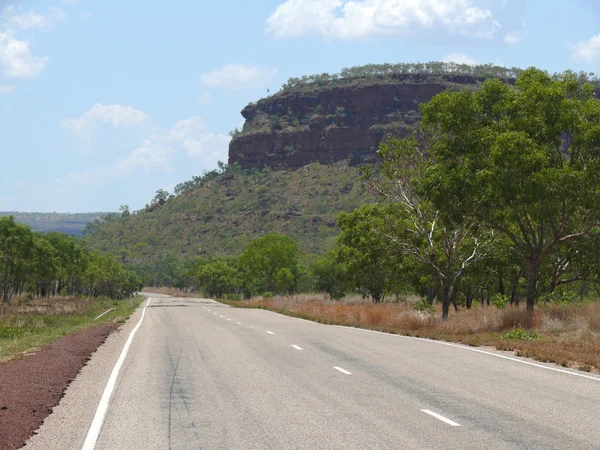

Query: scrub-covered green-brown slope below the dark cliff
[86,161,374,263]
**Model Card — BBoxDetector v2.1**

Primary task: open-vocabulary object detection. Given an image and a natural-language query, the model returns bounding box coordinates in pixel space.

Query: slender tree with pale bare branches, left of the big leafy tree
[365,133,489,320]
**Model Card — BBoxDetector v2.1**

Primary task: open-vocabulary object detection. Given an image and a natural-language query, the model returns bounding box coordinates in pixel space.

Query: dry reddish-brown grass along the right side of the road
[227,295,600,373]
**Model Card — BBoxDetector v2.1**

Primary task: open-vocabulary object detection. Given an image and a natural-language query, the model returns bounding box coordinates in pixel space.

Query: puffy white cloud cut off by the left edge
[0,30,48,78]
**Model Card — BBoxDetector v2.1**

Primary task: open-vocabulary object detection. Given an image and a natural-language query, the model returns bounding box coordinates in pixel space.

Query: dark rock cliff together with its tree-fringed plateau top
[229,62,598,169]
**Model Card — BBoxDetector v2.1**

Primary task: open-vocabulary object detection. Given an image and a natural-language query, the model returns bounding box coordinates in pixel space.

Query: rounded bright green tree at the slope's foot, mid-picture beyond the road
[239,234,299,292]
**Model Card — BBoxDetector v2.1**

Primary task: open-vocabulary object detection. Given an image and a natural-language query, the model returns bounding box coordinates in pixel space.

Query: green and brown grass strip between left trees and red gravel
[0,296,145,362]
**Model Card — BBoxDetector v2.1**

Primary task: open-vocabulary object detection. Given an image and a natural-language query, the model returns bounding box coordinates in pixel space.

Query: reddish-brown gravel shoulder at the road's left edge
[0,323,118,450]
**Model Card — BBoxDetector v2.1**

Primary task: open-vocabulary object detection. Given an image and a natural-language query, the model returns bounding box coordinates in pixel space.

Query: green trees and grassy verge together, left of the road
[0,216,143,361]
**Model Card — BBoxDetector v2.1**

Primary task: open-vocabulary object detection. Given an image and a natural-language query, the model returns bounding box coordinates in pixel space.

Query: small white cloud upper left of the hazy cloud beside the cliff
[61,103,151,141]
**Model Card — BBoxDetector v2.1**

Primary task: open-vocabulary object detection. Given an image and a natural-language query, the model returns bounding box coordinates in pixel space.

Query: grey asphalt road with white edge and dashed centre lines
[26,296,600,450]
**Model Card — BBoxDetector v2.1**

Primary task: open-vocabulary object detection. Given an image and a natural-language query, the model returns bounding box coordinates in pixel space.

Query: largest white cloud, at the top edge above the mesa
[266,0,502,39]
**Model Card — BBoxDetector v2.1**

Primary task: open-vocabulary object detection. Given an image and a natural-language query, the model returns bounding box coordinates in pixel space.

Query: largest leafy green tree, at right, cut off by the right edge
[422,69,600,312]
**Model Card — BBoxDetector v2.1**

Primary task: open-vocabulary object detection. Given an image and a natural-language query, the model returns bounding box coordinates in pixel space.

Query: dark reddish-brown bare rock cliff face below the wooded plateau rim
[229,75,492,169]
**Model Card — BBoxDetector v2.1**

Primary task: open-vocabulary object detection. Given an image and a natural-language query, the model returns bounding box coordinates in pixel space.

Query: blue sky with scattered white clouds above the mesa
[0,0,600,212]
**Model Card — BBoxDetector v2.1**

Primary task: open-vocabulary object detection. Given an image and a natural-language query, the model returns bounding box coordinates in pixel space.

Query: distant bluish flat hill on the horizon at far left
[0,211,106,236]
